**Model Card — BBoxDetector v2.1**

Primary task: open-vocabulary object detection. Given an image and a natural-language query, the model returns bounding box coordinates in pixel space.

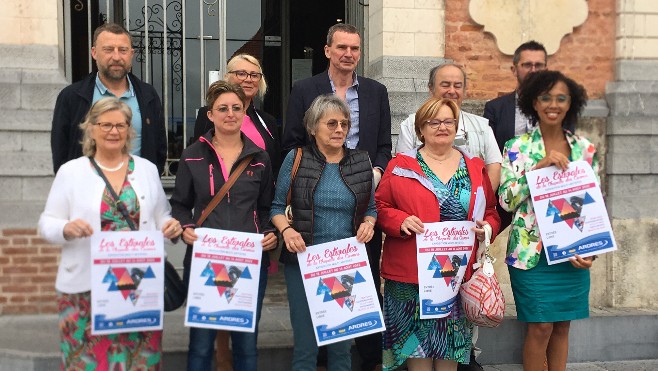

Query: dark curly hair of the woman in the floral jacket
[519,71,587,128]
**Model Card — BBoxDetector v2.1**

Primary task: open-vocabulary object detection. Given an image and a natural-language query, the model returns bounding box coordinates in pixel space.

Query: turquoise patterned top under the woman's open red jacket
[416,151,471,221]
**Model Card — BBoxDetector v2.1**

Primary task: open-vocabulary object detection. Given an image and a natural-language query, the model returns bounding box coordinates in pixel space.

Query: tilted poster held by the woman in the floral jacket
[526,161,617,264]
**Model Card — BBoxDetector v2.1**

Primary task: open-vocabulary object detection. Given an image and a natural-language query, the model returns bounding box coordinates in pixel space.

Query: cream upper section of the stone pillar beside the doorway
[368,0,445,61]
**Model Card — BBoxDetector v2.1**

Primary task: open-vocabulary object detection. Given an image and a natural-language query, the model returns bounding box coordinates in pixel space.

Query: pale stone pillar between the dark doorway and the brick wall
[364,0,445,151]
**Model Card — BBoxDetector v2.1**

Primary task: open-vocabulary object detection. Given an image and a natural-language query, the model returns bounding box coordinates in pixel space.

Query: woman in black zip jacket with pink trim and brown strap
[171,81,277,371]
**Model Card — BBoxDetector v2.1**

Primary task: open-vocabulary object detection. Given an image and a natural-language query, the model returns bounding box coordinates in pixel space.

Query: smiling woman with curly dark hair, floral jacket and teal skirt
[498,71,598,371]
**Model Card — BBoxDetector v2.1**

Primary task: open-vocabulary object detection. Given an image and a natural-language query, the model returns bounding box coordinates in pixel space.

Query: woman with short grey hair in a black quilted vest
[271,95,377,370]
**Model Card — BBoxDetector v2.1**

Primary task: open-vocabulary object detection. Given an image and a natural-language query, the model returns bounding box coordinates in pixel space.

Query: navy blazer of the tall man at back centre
[281,71,393,170]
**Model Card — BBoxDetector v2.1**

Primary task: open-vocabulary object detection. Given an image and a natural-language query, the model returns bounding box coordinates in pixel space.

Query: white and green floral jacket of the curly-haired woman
[498,127,599,269]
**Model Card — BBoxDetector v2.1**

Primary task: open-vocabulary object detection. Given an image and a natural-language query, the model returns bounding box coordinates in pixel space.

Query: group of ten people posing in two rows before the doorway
[39,19,598,371]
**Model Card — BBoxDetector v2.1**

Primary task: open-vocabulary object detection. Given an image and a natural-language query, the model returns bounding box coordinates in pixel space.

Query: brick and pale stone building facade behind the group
[0,0,658,315]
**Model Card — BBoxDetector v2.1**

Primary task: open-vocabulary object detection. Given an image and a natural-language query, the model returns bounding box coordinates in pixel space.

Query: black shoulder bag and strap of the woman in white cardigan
[89,157,187,312]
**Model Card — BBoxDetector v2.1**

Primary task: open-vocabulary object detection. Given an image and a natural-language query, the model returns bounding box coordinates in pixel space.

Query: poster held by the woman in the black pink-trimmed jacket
[185,228,263,332]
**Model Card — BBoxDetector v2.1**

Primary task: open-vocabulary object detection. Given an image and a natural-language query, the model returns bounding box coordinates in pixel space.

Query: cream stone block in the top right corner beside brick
[616,0,658,59]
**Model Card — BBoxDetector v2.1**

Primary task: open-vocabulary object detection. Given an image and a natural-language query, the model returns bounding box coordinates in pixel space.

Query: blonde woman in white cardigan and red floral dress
[39,98,182,370]
